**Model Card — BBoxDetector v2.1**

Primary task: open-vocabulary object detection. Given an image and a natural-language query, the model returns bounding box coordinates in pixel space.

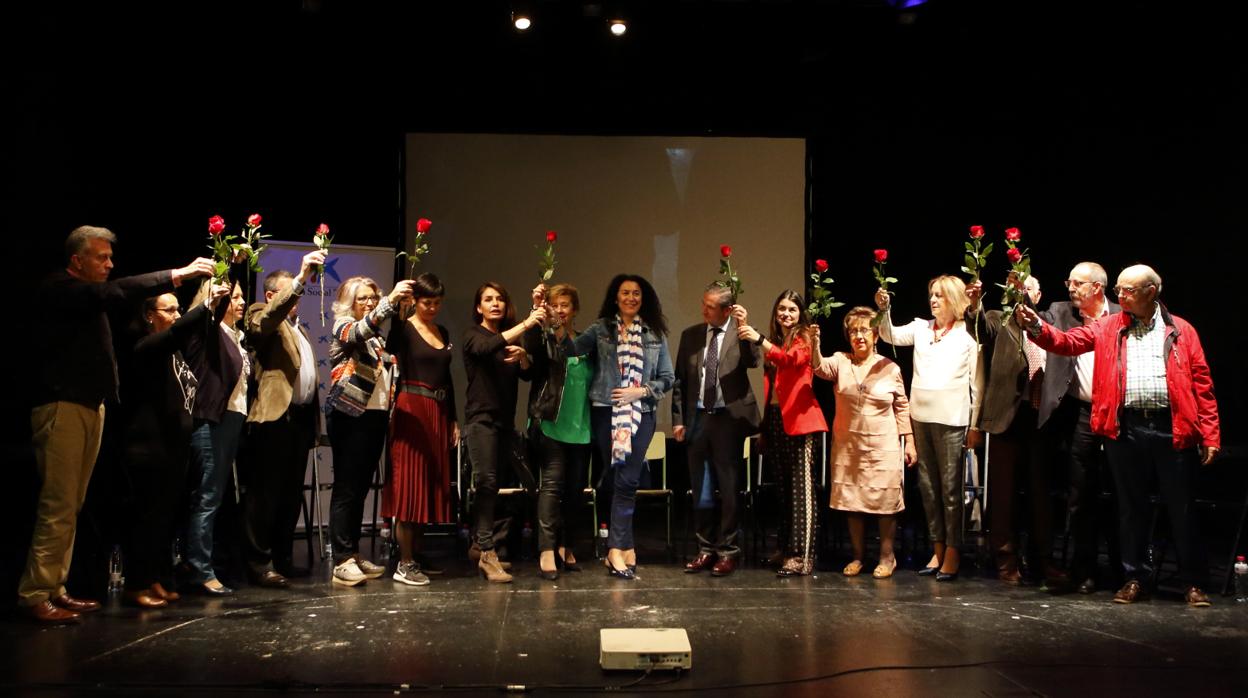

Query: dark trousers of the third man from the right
[988,403,1053,561]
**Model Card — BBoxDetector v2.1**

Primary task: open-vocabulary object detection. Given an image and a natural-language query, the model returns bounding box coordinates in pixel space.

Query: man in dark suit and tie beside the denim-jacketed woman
[671,283,763,577]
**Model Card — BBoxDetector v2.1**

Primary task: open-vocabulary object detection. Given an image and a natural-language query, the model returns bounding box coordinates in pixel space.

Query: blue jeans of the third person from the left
[183,411,247,584]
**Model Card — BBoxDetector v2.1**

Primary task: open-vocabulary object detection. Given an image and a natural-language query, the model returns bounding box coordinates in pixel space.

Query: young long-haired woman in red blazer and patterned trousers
[736,291,827,577]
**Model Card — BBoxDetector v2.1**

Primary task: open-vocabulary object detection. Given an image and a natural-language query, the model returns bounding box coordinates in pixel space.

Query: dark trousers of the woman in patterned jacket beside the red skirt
[327,410,389,564]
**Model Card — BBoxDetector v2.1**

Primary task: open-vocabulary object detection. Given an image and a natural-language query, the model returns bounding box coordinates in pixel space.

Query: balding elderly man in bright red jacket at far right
[1017,265,1222,607]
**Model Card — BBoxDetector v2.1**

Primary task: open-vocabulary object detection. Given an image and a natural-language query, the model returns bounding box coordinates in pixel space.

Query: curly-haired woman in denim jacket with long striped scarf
[565,273,675,579]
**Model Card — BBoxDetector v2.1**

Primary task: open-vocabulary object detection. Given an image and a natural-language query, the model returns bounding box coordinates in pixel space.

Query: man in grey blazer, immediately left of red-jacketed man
[1037,262,1122,594]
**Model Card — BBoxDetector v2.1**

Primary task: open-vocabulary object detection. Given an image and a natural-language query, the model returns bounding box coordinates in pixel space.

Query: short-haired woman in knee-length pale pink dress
[812,306,919,579]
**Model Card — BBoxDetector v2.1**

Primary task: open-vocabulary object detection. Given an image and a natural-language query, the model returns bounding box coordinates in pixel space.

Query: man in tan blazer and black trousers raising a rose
[238,250,326,588]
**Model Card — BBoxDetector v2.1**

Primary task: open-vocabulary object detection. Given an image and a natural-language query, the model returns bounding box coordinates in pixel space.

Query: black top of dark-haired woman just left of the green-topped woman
[463,325,532,428]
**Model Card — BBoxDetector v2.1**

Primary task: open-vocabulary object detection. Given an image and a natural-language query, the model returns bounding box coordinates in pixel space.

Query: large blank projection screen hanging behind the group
[404,134,806,433]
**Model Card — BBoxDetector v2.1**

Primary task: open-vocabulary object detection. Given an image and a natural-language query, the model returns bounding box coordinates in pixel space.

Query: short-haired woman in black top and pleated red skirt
[382,273,459,587]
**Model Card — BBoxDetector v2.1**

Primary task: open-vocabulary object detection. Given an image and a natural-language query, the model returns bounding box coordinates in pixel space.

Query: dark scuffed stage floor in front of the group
[0,558,1248,697]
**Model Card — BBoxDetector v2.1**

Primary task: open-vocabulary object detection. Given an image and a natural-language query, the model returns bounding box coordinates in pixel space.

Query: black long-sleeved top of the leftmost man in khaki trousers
[31,271,173,408]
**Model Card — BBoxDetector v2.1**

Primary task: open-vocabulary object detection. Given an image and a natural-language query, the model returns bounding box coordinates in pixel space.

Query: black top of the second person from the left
[121,303,212,466]
